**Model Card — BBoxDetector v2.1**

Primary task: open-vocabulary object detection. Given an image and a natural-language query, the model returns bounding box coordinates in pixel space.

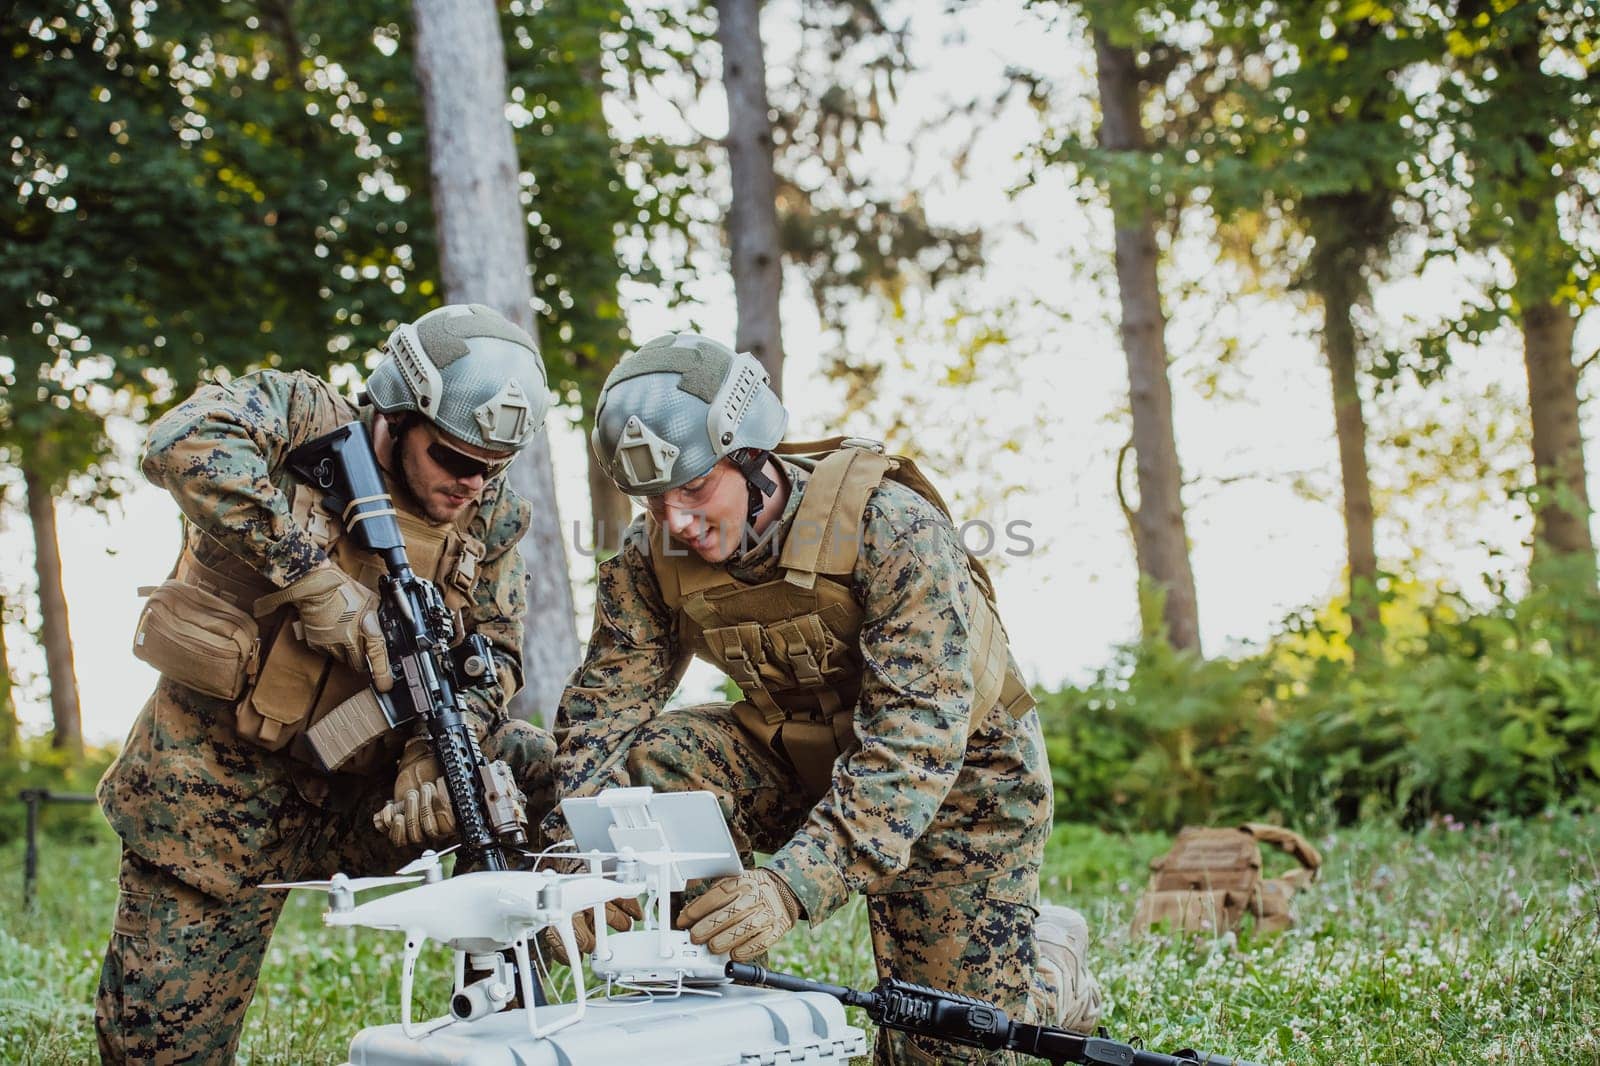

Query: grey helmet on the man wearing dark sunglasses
[366,304,550,451]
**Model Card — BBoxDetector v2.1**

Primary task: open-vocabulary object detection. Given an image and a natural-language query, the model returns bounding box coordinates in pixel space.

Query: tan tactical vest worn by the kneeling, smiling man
[645,437,1034,795]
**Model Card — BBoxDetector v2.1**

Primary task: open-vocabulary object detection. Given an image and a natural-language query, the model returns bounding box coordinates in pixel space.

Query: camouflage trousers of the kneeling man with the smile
[624,704,1058,1066]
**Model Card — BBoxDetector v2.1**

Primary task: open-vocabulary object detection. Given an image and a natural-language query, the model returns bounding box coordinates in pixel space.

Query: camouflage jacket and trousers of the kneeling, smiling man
[546,463,1053,1061]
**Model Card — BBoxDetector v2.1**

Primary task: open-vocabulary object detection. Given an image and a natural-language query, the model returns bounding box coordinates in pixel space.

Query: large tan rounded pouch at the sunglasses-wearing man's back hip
[133,579,261,699]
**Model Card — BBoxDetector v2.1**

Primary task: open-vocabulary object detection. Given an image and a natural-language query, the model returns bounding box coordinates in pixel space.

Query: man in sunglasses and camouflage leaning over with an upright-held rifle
[96,304,555,1063]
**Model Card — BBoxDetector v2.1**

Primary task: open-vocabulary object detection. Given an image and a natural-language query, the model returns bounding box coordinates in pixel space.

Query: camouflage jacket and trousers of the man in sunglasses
[96,371,555,1063]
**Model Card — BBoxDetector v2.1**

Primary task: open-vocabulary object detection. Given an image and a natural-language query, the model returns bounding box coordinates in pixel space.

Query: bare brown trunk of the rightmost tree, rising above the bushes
[1522,294,1595,565]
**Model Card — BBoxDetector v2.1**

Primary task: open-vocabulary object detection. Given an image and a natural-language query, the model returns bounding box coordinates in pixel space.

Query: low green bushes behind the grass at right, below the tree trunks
[1040,560,1600,828]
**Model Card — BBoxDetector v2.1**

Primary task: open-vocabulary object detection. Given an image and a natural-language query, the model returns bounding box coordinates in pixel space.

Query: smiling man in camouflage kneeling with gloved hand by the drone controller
[546,335,1099,1063]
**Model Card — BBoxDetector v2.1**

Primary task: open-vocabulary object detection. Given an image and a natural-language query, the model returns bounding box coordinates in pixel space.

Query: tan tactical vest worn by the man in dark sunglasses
[164,473,485,773]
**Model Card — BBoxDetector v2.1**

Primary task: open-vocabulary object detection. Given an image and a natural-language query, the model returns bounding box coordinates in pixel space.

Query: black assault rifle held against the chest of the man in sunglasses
[288,423,528,869]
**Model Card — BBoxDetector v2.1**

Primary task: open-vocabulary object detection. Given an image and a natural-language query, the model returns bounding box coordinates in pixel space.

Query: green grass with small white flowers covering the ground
[0,813,1600,1064]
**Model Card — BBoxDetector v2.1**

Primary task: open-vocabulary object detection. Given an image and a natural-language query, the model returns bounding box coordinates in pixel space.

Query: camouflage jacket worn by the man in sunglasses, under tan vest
[99,370,530,892]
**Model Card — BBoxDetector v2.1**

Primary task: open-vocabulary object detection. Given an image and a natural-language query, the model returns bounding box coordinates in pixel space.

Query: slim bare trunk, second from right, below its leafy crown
[1314,271,1381,646]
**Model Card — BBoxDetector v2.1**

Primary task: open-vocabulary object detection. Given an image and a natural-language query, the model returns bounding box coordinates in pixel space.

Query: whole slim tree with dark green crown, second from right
[1186,0,1430,658]
